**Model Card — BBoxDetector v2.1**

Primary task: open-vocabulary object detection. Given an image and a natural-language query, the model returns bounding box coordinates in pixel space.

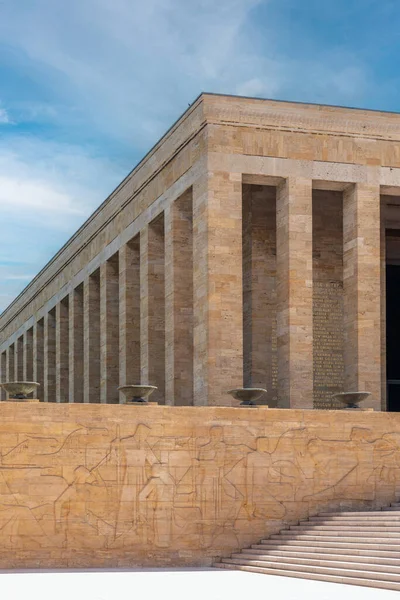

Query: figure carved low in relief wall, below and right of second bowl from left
[139,463,175,548]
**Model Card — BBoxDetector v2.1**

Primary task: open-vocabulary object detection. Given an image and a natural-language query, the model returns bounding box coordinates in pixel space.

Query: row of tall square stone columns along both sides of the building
[0,170,382,409]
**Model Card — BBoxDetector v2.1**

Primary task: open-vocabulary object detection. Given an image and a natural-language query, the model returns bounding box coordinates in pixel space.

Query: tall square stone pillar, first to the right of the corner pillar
[276,177,313,408]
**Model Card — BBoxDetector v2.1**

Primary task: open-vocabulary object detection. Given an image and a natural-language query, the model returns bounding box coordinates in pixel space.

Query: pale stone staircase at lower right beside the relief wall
[214,502,400,591]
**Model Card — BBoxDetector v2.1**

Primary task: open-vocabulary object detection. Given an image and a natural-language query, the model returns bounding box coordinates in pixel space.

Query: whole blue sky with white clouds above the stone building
[0,0,400,311]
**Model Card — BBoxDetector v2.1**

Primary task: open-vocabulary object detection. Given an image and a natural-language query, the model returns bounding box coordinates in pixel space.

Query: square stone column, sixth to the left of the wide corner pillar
[68,285,84,402]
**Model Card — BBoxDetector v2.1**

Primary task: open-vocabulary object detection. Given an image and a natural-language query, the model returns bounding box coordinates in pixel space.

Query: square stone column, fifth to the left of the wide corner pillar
[83,270,100,402]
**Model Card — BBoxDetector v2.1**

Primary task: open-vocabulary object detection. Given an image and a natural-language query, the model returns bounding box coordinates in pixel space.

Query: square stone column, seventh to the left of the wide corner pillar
[56,296,69,402]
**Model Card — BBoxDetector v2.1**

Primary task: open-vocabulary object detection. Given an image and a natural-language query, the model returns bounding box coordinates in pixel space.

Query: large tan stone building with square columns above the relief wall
[0,94,400,410]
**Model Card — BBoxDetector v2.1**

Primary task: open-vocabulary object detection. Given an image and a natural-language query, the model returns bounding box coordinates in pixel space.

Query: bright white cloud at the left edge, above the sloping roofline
[0,137,123,224]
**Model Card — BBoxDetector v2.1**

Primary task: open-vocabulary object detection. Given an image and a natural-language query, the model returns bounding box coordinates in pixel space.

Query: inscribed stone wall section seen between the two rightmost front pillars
[313,281,344,409]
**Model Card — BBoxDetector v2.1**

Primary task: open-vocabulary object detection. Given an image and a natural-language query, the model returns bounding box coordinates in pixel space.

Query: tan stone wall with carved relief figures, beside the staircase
[0,403,400,568]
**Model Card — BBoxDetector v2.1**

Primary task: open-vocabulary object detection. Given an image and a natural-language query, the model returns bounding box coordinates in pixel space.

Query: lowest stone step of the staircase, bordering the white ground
[214,563,400,591]
